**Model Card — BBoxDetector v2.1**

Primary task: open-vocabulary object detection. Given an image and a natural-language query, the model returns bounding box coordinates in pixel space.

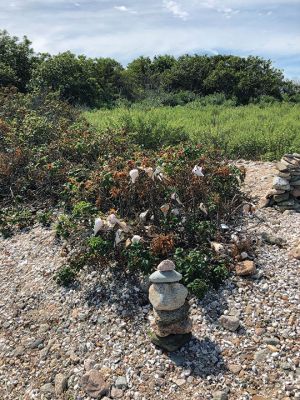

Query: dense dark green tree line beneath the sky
[0,31,300,108]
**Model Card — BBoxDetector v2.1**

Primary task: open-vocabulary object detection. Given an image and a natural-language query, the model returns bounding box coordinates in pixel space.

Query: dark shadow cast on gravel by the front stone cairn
[168,336,227,378]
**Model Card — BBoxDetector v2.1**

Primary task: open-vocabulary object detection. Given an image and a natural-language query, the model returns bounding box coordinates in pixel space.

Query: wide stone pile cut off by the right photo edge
[266,153,300,212]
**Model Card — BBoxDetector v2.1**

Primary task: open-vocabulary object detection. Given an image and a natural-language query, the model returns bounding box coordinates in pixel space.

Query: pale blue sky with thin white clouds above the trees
[0,0,300,80]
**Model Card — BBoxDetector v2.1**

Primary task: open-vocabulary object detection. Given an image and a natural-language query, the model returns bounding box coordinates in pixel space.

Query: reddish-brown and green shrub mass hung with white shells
[0,86,244,296]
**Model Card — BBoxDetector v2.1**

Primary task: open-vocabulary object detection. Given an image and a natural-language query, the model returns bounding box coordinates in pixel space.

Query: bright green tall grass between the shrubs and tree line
[85,102,300,160]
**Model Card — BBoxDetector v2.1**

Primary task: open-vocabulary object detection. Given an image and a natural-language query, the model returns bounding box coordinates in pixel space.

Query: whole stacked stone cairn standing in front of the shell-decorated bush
[149,260,192,351]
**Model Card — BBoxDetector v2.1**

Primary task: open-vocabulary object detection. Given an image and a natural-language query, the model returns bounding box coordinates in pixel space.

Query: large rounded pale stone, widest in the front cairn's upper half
[149,283,188,310]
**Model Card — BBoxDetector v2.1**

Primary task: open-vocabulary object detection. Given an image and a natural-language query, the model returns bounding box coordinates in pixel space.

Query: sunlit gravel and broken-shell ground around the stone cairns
[0,162,300,400]
